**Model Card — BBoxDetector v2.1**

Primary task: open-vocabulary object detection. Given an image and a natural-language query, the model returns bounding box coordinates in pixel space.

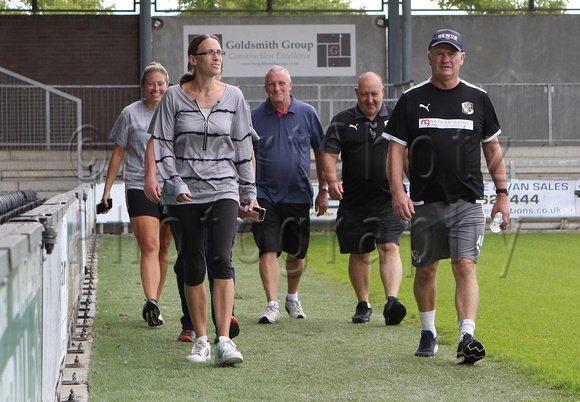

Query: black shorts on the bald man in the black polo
[336,203,405,254]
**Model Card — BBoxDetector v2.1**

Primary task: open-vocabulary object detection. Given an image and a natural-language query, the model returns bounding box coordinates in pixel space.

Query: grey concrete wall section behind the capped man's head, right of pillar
[413,15,580,83]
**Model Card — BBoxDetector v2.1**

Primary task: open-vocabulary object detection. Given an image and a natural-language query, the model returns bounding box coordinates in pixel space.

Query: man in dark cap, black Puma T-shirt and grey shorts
[383,29,510,364]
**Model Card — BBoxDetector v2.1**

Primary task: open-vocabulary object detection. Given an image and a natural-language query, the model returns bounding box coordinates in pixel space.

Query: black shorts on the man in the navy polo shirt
[252,198,310,259]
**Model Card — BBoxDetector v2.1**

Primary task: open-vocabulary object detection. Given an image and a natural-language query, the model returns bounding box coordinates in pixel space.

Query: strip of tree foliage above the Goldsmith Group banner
[178,0,352,15]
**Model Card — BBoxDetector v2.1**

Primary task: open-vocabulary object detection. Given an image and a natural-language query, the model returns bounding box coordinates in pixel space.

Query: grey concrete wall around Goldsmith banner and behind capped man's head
[153,15,580,85]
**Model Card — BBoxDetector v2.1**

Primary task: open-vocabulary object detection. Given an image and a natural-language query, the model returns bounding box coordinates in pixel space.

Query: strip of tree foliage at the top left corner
[0,0,115,14]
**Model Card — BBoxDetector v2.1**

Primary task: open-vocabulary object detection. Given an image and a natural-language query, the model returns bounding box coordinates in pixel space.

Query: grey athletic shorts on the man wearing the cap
[411,200,485,268]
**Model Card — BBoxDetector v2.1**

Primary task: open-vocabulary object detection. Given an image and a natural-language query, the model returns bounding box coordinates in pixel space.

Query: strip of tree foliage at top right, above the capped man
[437,0,568,14]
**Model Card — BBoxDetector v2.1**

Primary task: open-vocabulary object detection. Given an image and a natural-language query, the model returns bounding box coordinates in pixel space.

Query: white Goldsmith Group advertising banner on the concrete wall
[183,24,356,77]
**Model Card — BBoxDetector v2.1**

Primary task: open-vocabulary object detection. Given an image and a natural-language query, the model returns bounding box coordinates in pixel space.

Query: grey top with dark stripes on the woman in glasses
[148,85,256,205]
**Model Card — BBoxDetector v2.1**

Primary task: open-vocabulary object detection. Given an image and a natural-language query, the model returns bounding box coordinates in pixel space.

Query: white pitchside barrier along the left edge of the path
[0,184,96,401]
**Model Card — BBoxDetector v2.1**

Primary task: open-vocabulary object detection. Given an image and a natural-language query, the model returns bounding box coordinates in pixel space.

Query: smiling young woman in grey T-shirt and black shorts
[102,62,171,327]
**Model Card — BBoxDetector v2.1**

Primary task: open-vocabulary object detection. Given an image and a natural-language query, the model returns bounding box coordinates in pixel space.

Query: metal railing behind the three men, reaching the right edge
[240,83,580,146]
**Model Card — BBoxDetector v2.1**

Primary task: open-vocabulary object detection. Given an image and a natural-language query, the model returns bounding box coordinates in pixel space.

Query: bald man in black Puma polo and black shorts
[322,72,407,325]
